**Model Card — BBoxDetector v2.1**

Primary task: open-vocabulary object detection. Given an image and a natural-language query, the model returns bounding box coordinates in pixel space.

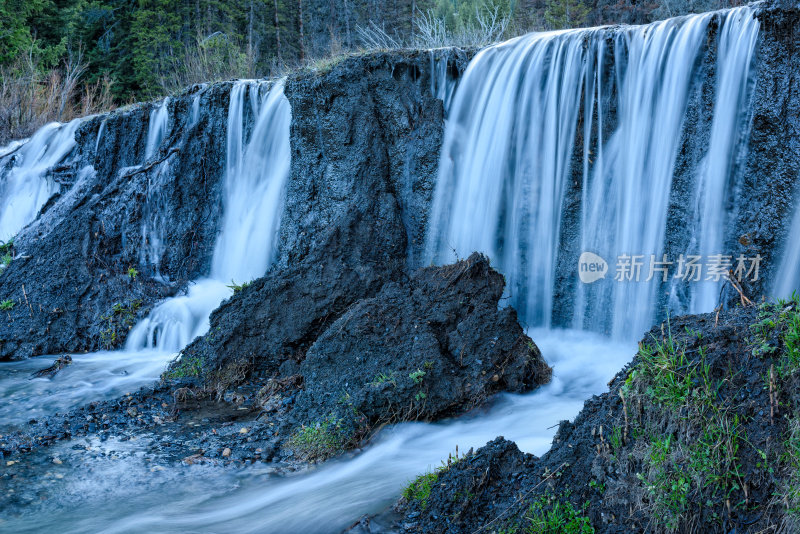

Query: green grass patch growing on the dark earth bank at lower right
[621,321,749,531]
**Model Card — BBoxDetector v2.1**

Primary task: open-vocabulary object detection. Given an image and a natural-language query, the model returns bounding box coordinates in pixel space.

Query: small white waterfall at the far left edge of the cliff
[0,119,81,242]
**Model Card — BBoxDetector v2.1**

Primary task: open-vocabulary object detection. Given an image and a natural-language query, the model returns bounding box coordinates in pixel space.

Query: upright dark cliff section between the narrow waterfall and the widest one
[279,49,470,268]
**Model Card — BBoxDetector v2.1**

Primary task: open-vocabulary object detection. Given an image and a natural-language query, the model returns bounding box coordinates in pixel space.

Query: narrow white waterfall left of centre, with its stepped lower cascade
[125,80,291,352]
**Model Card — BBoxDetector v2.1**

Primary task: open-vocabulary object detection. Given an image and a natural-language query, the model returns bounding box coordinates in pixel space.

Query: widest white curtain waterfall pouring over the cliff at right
[426,8,758,336]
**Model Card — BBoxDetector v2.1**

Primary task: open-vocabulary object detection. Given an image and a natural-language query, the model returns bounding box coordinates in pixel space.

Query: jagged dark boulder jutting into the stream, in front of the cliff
[294,254,550,434]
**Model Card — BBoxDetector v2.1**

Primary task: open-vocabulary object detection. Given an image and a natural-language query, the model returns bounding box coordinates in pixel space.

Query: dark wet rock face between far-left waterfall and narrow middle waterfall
[0,84,230,360]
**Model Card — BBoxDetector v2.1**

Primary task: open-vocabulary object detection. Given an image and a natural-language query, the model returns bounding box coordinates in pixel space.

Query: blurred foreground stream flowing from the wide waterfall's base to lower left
[0,330,635,534]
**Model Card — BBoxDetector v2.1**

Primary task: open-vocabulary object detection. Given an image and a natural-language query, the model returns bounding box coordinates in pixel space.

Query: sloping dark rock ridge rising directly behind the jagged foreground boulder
[183,161,405,388]
